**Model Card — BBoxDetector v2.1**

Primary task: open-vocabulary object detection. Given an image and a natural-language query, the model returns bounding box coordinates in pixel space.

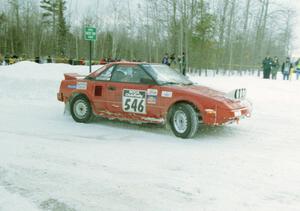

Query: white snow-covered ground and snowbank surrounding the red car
[0,62,300,211]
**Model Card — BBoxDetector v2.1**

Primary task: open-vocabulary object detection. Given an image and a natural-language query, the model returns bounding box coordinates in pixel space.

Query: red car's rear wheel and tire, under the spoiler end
[70,95,93,123]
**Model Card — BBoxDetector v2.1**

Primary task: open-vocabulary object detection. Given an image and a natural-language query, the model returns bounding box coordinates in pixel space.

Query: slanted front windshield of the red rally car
[142,64,193,85]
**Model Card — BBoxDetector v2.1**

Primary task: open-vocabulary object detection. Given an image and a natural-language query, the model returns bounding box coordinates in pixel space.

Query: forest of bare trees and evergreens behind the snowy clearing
[0,0,299,69]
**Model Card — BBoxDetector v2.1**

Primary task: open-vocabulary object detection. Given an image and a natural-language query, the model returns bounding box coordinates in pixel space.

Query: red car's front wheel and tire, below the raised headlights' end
[170,103,199,139]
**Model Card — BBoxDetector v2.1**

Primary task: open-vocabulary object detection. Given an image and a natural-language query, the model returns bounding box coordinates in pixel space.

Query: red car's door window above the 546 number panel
[111,65,152,83]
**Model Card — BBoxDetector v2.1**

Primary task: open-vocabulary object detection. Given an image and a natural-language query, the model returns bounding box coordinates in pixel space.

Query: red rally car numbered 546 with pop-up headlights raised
[57,62,251,138]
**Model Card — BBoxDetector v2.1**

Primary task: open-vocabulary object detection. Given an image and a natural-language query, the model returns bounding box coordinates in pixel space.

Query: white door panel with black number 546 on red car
[122,89,147,114]
